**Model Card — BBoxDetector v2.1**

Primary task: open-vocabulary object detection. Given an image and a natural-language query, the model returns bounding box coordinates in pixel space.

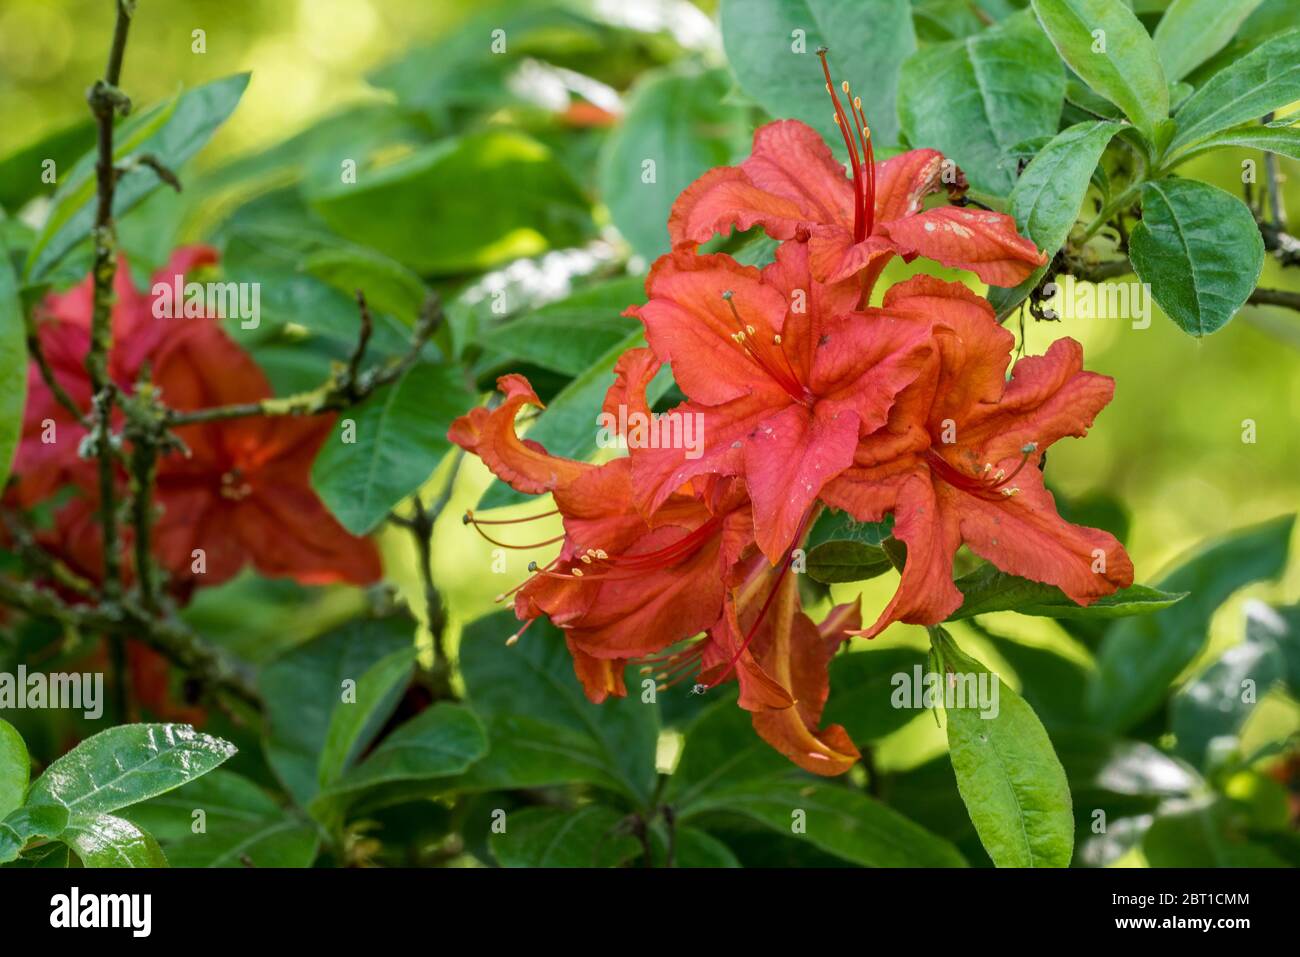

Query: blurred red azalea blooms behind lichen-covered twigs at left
[7,247,381,598]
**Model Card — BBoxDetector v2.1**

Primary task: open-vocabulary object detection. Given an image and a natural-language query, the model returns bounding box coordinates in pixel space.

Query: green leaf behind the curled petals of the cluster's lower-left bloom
[478,330,672,508]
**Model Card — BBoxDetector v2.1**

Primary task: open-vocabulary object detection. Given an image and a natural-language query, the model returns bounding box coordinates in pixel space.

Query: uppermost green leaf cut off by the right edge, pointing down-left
[1170,30,1300,150]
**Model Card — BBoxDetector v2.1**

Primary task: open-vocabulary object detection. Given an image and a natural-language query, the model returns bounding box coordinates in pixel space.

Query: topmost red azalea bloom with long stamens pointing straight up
[668,55,1047,294]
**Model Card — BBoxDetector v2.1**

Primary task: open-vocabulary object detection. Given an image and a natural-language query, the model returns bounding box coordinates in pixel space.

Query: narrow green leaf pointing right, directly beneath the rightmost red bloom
[948,563,1186,622]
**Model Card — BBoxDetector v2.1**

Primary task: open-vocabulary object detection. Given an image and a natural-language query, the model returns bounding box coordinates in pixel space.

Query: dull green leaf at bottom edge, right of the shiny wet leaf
[122,770,320,867]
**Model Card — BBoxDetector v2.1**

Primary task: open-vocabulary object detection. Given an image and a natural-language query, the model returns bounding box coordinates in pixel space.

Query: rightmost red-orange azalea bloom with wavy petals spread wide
[823,276,1134,637]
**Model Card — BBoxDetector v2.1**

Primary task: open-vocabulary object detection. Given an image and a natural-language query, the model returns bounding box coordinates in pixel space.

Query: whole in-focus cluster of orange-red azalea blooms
[450,72,1132,775]
